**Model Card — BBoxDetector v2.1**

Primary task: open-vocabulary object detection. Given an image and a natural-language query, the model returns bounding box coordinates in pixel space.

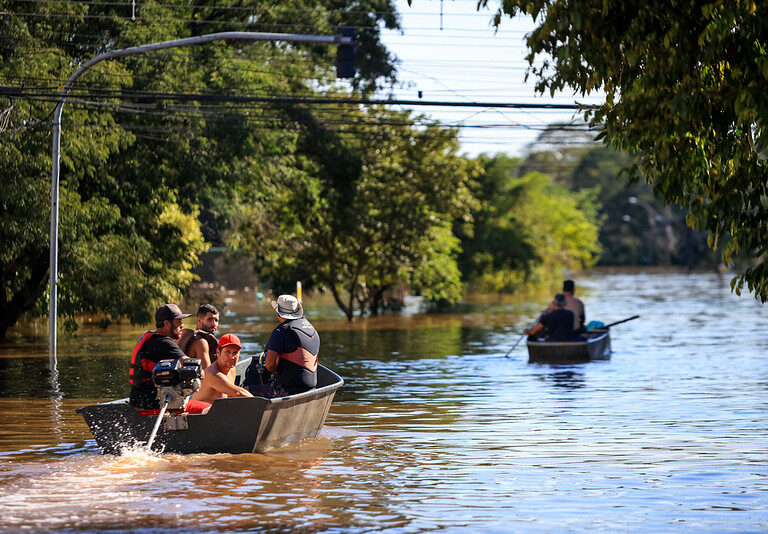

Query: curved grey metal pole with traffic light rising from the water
[48,27,355,364]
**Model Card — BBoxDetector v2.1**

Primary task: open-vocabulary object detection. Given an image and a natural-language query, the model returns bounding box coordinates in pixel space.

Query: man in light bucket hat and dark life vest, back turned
[250,295,320,398]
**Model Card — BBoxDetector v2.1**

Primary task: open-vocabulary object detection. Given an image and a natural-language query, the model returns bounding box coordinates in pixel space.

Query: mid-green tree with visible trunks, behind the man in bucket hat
[233,108,474,319]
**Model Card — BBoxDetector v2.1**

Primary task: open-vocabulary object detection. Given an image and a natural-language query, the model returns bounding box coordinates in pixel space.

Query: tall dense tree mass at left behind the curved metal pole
[0,0,398,337]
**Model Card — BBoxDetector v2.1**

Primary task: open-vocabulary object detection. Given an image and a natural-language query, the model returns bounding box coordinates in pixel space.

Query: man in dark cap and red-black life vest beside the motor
[128,304,211,415]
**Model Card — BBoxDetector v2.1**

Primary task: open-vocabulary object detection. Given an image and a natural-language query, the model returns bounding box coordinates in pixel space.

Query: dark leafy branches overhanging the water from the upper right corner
[480,0,768,302]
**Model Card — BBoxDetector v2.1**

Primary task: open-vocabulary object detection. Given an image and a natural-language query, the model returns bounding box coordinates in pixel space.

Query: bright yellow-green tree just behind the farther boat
[458,154,600,292]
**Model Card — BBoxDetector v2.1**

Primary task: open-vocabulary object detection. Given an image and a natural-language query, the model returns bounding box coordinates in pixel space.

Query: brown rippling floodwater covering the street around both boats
[0,273,768,533]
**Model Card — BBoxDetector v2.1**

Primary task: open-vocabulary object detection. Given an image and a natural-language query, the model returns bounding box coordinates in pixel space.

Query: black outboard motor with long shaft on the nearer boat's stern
[147,358,203,449]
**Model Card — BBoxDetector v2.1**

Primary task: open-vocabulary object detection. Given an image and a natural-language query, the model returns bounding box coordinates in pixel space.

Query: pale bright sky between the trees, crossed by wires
[383,0,601,156]
